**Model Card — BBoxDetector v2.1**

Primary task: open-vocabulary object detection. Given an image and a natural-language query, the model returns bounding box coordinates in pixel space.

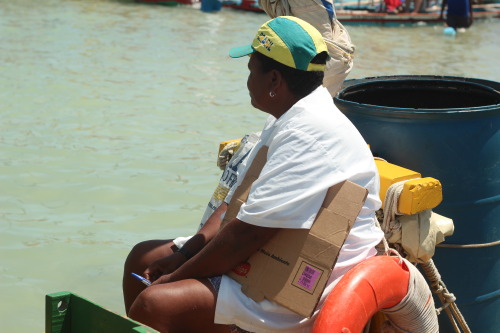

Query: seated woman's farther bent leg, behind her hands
[123,240,177,314]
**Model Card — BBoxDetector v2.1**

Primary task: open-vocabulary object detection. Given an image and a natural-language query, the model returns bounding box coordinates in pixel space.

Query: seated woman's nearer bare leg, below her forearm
[129,279,230,333]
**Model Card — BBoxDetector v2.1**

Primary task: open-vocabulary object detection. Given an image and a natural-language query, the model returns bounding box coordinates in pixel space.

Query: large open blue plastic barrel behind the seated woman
[334,76,500,333]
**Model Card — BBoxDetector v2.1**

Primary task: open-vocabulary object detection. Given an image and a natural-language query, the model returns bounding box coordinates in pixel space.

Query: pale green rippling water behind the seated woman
[0,0,500,332]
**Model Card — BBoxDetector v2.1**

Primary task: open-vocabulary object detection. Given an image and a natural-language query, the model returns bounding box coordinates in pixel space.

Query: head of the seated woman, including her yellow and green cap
[229,16,329,115]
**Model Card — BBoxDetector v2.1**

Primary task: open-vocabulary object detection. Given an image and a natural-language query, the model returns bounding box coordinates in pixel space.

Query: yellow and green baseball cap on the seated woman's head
[229,16,328,72]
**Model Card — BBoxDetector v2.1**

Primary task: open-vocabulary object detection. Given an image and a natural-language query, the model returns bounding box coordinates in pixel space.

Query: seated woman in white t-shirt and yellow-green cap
[128,17,382,332]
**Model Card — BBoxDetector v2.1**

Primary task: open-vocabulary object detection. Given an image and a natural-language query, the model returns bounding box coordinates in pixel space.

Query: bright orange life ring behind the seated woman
[312,256,410,333]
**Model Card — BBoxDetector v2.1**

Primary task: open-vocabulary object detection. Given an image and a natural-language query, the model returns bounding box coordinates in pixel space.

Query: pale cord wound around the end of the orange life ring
[381,259,439,333]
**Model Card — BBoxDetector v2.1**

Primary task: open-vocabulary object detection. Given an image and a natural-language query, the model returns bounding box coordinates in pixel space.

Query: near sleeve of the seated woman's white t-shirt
[237,129,341,229]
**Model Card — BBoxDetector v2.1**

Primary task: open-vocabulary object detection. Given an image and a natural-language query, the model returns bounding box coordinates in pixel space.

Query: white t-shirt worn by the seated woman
[215,87,383,333]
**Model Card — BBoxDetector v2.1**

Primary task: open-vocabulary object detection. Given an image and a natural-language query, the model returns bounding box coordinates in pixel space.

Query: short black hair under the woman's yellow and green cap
[252,51,328,99]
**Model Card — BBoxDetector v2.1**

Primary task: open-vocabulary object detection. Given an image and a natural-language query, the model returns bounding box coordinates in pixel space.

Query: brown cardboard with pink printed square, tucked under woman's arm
[223,146,368,317]
